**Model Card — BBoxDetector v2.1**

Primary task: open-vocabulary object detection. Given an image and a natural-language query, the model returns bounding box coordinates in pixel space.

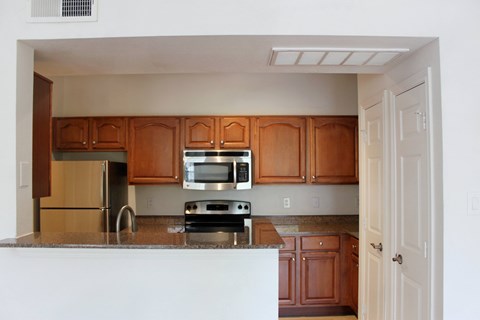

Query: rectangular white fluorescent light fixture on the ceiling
[270,48,410,66]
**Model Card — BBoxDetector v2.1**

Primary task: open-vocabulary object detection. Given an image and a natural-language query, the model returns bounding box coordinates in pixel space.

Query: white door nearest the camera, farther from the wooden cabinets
[389,83,429,320]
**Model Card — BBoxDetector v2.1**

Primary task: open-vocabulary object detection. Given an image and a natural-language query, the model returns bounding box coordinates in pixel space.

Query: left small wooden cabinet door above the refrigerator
[54,118,89,150]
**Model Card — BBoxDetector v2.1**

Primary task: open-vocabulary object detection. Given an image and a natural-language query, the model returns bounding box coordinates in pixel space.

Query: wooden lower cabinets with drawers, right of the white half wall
[278,234,354,316]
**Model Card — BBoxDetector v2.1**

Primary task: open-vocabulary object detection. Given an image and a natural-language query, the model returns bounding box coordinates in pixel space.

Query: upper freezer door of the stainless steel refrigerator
[40,161,109,208]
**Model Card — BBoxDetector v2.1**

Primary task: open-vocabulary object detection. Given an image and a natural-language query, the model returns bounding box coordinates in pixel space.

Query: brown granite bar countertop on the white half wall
[0,219,284,249]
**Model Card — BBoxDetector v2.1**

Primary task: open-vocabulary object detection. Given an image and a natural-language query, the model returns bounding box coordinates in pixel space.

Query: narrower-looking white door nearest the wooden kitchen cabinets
[359,103,385,320]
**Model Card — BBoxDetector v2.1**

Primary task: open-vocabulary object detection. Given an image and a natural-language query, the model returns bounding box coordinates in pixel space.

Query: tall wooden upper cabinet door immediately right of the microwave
[254,117,306,183]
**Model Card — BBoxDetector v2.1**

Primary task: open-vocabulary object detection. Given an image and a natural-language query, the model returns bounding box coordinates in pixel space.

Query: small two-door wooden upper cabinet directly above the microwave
[184,117,250,149]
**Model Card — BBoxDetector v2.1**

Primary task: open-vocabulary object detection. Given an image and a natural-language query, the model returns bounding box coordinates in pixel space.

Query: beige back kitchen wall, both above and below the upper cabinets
[52,74,358,215]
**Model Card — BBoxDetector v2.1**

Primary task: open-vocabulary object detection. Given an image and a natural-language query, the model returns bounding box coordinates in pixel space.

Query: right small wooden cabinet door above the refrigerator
[90,117,127,150]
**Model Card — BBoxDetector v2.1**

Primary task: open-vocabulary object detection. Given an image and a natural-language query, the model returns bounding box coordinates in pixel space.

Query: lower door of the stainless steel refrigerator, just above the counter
[40,209,109,232]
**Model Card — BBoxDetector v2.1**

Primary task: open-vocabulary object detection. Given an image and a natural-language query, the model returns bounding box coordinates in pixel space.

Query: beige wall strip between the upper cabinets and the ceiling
[52,74,357,116]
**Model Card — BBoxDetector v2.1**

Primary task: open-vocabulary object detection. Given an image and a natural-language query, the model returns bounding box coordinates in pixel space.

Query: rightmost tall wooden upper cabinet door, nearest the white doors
[310,117,358,183]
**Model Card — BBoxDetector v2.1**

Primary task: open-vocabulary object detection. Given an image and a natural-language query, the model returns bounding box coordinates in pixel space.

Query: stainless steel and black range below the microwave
[185,200,251,232]
